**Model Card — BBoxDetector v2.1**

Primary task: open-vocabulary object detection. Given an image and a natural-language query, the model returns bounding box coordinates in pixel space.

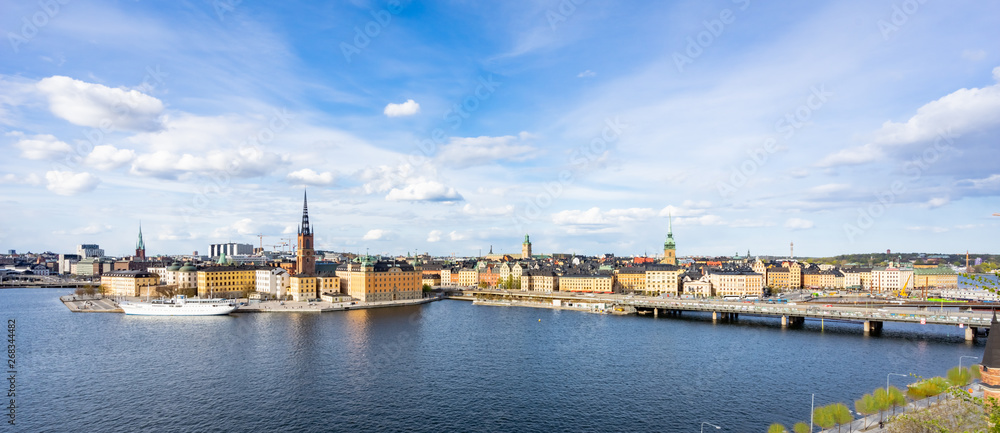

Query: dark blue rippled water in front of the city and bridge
[0,289,985,432]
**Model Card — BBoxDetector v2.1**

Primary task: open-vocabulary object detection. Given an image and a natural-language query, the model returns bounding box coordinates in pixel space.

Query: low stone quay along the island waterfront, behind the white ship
[59,295,443,313]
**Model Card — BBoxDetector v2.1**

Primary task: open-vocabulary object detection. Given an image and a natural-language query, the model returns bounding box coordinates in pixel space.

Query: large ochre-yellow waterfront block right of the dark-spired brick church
[340,256,424,302]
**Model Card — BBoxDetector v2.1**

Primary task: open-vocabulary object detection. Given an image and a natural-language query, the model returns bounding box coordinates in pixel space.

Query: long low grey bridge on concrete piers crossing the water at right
[462,290,992,341]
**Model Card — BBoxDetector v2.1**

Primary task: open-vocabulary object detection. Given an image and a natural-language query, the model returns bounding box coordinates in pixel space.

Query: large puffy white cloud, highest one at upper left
[37,75,163,131]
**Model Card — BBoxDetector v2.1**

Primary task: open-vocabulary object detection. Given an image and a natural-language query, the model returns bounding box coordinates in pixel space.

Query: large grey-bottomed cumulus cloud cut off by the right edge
[818,67,1000,167]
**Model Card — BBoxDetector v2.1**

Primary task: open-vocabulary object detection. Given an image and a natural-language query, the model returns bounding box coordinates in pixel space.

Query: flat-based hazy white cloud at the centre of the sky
[437,132,537,168]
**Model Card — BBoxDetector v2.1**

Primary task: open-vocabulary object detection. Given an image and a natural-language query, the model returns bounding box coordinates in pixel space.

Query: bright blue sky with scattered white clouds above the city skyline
[0,0,1000,257]
